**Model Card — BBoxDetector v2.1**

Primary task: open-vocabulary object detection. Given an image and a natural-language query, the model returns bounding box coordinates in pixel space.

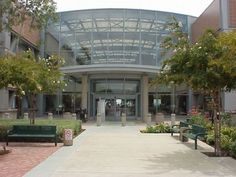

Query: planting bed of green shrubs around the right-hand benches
[140,113,236,158]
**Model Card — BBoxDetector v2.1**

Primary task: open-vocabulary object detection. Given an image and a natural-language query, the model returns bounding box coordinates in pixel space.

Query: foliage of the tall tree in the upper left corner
[0,0,56,32]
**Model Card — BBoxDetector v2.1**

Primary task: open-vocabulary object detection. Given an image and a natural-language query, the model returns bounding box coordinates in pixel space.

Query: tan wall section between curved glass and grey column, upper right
[192,0,221,42]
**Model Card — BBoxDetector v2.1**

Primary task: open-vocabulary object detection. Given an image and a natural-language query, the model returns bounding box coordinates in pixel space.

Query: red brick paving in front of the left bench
[0,142,62,177]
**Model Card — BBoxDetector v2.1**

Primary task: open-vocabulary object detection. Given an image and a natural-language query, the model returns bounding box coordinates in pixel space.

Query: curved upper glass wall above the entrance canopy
[45,9,188,66]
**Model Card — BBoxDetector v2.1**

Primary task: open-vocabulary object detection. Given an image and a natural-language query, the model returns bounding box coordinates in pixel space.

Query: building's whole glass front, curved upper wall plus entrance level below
[43,9,193,120]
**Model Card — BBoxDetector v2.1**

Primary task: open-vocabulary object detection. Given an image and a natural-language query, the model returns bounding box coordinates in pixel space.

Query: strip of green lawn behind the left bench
[0,118,82,141]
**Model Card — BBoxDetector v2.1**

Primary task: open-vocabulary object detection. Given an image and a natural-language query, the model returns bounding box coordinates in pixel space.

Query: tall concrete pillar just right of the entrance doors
[142,75,148,122]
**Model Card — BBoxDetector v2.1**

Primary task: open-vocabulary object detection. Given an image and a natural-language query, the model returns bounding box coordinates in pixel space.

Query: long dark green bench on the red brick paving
[6,125,57,146]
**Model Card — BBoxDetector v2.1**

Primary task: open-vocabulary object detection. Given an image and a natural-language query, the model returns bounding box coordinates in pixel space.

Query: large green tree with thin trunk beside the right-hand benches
[154,19,236,155]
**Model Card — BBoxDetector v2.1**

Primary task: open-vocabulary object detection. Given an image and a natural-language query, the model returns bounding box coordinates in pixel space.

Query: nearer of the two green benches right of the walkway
[182,124,207,149]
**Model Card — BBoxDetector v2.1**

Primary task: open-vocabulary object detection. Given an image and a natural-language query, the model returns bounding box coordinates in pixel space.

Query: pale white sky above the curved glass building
[54,0,213,17]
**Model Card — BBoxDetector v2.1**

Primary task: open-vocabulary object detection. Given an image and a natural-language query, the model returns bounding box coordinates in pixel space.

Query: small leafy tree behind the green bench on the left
[0,51,64,124]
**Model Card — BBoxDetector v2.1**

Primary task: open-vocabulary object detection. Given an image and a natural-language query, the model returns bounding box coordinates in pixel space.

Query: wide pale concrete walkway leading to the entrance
[24,123,236,177]
